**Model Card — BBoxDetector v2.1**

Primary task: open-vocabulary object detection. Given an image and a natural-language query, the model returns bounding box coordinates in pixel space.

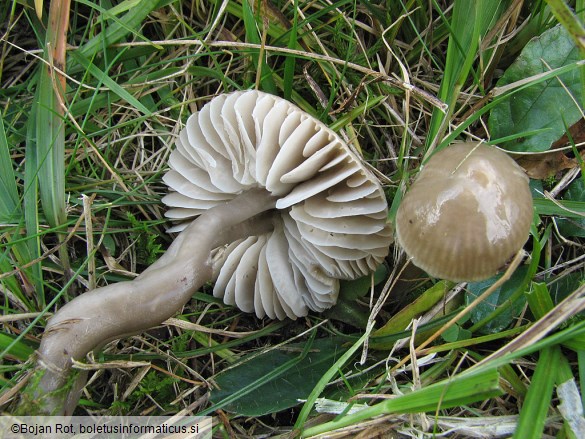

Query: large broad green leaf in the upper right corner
[489,25,583,152]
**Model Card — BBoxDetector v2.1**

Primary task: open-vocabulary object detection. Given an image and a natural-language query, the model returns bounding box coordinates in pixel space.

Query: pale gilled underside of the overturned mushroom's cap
[163,91,392,319]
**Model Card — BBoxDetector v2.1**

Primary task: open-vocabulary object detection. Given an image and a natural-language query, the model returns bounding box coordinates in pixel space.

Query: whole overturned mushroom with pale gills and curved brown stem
[28,91,392,414]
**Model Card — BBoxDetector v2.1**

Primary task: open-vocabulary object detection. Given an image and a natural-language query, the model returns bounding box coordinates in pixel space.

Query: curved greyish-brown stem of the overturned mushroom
[30,189,276,415]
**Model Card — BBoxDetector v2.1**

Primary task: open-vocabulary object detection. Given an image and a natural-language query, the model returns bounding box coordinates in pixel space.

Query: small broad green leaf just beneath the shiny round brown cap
[465,267,528,334]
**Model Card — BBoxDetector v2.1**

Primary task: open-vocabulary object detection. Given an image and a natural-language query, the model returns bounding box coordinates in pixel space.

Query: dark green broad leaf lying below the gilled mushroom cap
[211,338,344,416]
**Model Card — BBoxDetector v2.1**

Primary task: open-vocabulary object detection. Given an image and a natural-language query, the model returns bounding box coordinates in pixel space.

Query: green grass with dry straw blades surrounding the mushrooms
[0,0,585,438]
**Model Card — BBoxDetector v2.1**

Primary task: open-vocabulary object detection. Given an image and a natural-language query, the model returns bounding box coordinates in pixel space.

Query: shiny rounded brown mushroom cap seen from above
[396,142,533,281]
